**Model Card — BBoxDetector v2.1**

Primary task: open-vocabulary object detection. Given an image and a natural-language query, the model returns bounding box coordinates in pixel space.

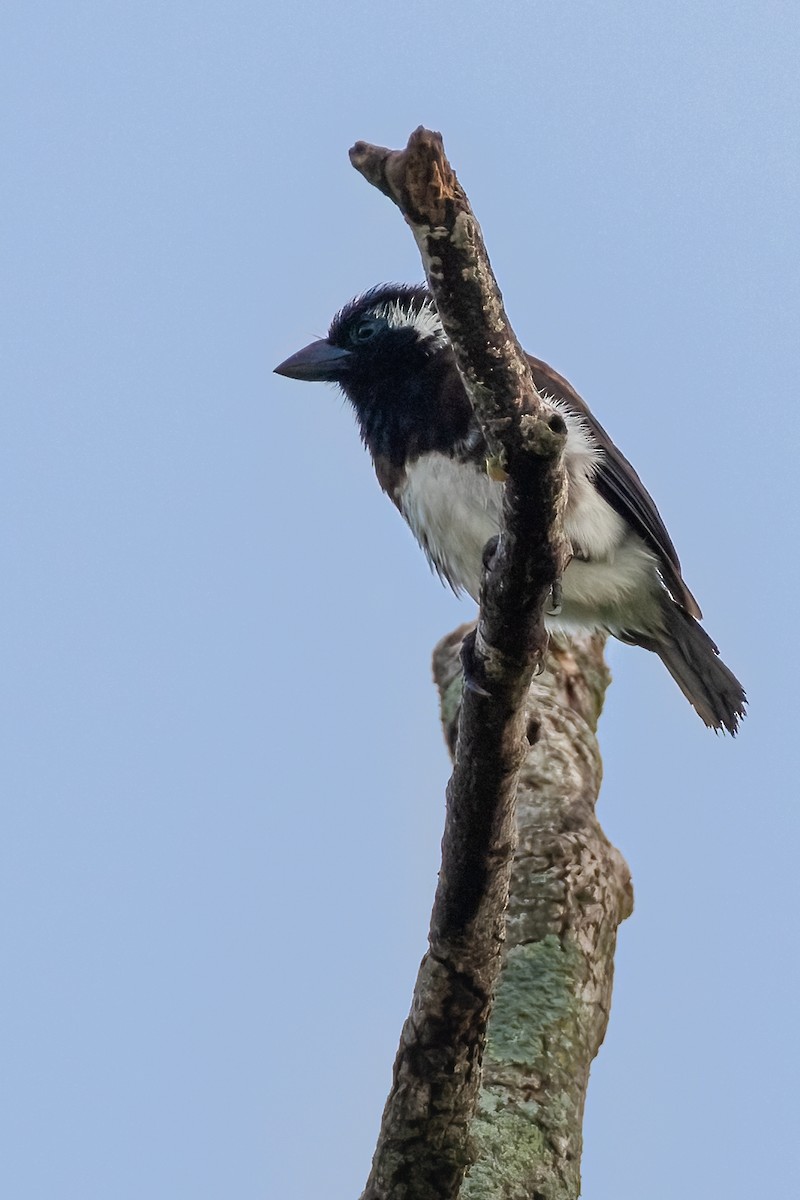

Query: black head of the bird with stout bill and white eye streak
[275,283,471,462]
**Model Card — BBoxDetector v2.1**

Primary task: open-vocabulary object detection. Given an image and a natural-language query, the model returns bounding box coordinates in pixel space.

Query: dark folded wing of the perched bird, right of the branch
[528,354,703,619]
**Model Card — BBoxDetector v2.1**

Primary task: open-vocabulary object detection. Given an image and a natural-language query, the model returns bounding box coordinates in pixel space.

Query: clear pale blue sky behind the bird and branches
[0,0,800,1200]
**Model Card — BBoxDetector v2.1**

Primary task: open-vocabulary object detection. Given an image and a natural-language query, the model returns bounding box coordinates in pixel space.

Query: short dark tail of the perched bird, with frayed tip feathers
[631,596,746,734]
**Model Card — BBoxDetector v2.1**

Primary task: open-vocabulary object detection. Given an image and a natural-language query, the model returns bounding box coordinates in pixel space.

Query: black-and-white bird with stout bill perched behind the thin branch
[275,283,746,734]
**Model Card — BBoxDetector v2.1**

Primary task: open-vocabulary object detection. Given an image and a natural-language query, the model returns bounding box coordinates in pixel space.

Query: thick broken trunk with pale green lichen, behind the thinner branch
[433,629,633,1200]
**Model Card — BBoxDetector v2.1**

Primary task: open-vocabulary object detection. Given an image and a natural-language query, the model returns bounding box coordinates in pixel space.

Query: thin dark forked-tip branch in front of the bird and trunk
[350,130,575,1200]
